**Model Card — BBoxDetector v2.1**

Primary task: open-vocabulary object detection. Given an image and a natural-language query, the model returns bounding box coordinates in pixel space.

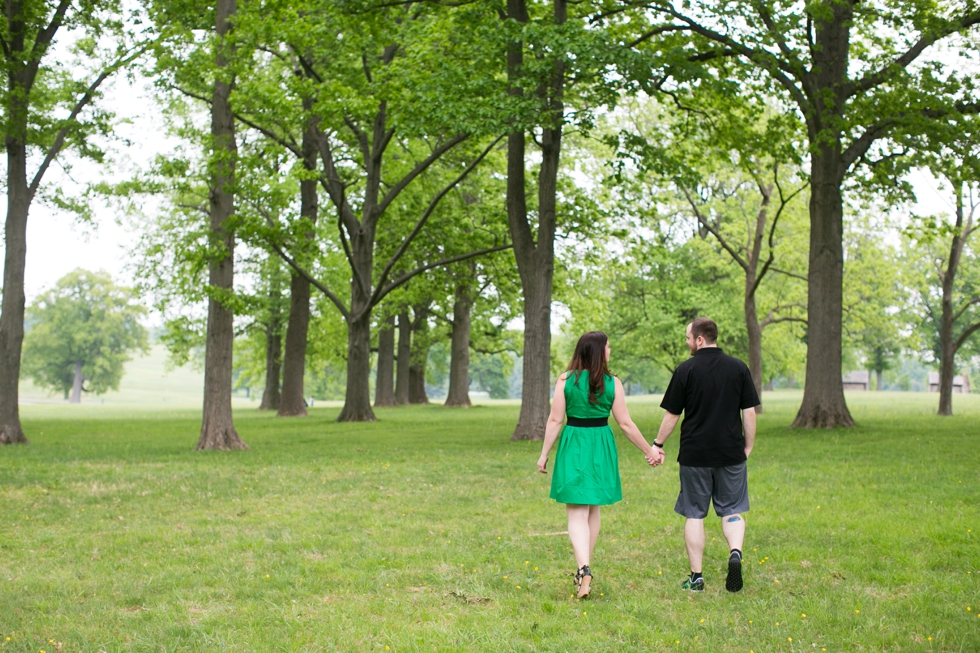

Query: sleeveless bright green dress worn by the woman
[551,371,623,506]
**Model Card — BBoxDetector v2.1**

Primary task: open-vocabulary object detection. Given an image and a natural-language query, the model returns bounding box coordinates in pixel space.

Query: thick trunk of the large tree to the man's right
[793,150,854,428]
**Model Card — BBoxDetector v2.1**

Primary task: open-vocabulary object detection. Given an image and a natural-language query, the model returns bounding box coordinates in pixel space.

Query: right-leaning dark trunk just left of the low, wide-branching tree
[277,105,319,417]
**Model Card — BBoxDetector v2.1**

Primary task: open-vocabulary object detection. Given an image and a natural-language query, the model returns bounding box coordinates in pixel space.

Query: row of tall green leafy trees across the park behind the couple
[0,0,980,449]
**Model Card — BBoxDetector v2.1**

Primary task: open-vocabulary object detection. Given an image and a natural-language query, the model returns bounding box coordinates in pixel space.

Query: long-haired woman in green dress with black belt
[538,331,662,599]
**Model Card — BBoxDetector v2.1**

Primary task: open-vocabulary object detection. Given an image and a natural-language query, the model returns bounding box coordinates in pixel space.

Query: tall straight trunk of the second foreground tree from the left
[197,0,248,450]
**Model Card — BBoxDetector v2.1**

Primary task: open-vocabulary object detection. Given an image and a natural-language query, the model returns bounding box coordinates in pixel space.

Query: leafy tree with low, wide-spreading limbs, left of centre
[230,2,509,421]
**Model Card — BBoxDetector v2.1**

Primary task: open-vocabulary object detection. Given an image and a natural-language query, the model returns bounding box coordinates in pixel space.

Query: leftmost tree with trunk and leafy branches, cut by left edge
[0,0,152,444]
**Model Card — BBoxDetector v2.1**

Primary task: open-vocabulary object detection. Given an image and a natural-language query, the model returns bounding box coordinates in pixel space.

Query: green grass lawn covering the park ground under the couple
[0,393,980,653]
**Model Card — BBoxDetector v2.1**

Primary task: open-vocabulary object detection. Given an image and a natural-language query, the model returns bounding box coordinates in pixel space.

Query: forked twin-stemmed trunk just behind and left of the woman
[506,0,567,440]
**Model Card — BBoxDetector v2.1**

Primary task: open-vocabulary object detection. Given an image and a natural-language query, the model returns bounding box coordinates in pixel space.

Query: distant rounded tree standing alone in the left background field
[24,270,149,404]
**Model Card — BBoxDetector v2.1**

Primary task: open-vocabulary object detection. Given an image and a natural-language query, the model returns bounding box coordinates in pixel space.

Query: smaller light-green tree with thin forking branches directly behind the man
[618,89,806,412]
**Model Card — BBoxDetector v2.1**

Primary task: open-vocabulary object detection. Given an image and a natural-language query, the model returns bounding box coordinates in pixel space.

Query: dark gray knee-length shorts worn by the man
[674,462,749,519]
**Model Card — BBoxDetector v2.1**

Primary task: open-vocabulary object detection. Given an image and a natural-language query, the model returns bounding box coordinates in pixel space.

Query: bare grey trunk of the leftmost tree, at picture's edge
[0,139,30,444]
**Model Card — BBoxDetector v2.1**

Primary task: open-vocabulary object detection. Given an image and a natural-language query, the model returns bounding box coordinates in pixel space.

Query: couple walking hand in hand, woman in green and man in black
[538,318,760,599]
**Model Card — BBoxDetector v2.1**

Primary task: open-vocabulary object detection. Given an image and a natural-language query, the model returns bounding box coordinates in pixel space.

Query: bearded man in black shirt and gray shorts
[653,317,760,592]
